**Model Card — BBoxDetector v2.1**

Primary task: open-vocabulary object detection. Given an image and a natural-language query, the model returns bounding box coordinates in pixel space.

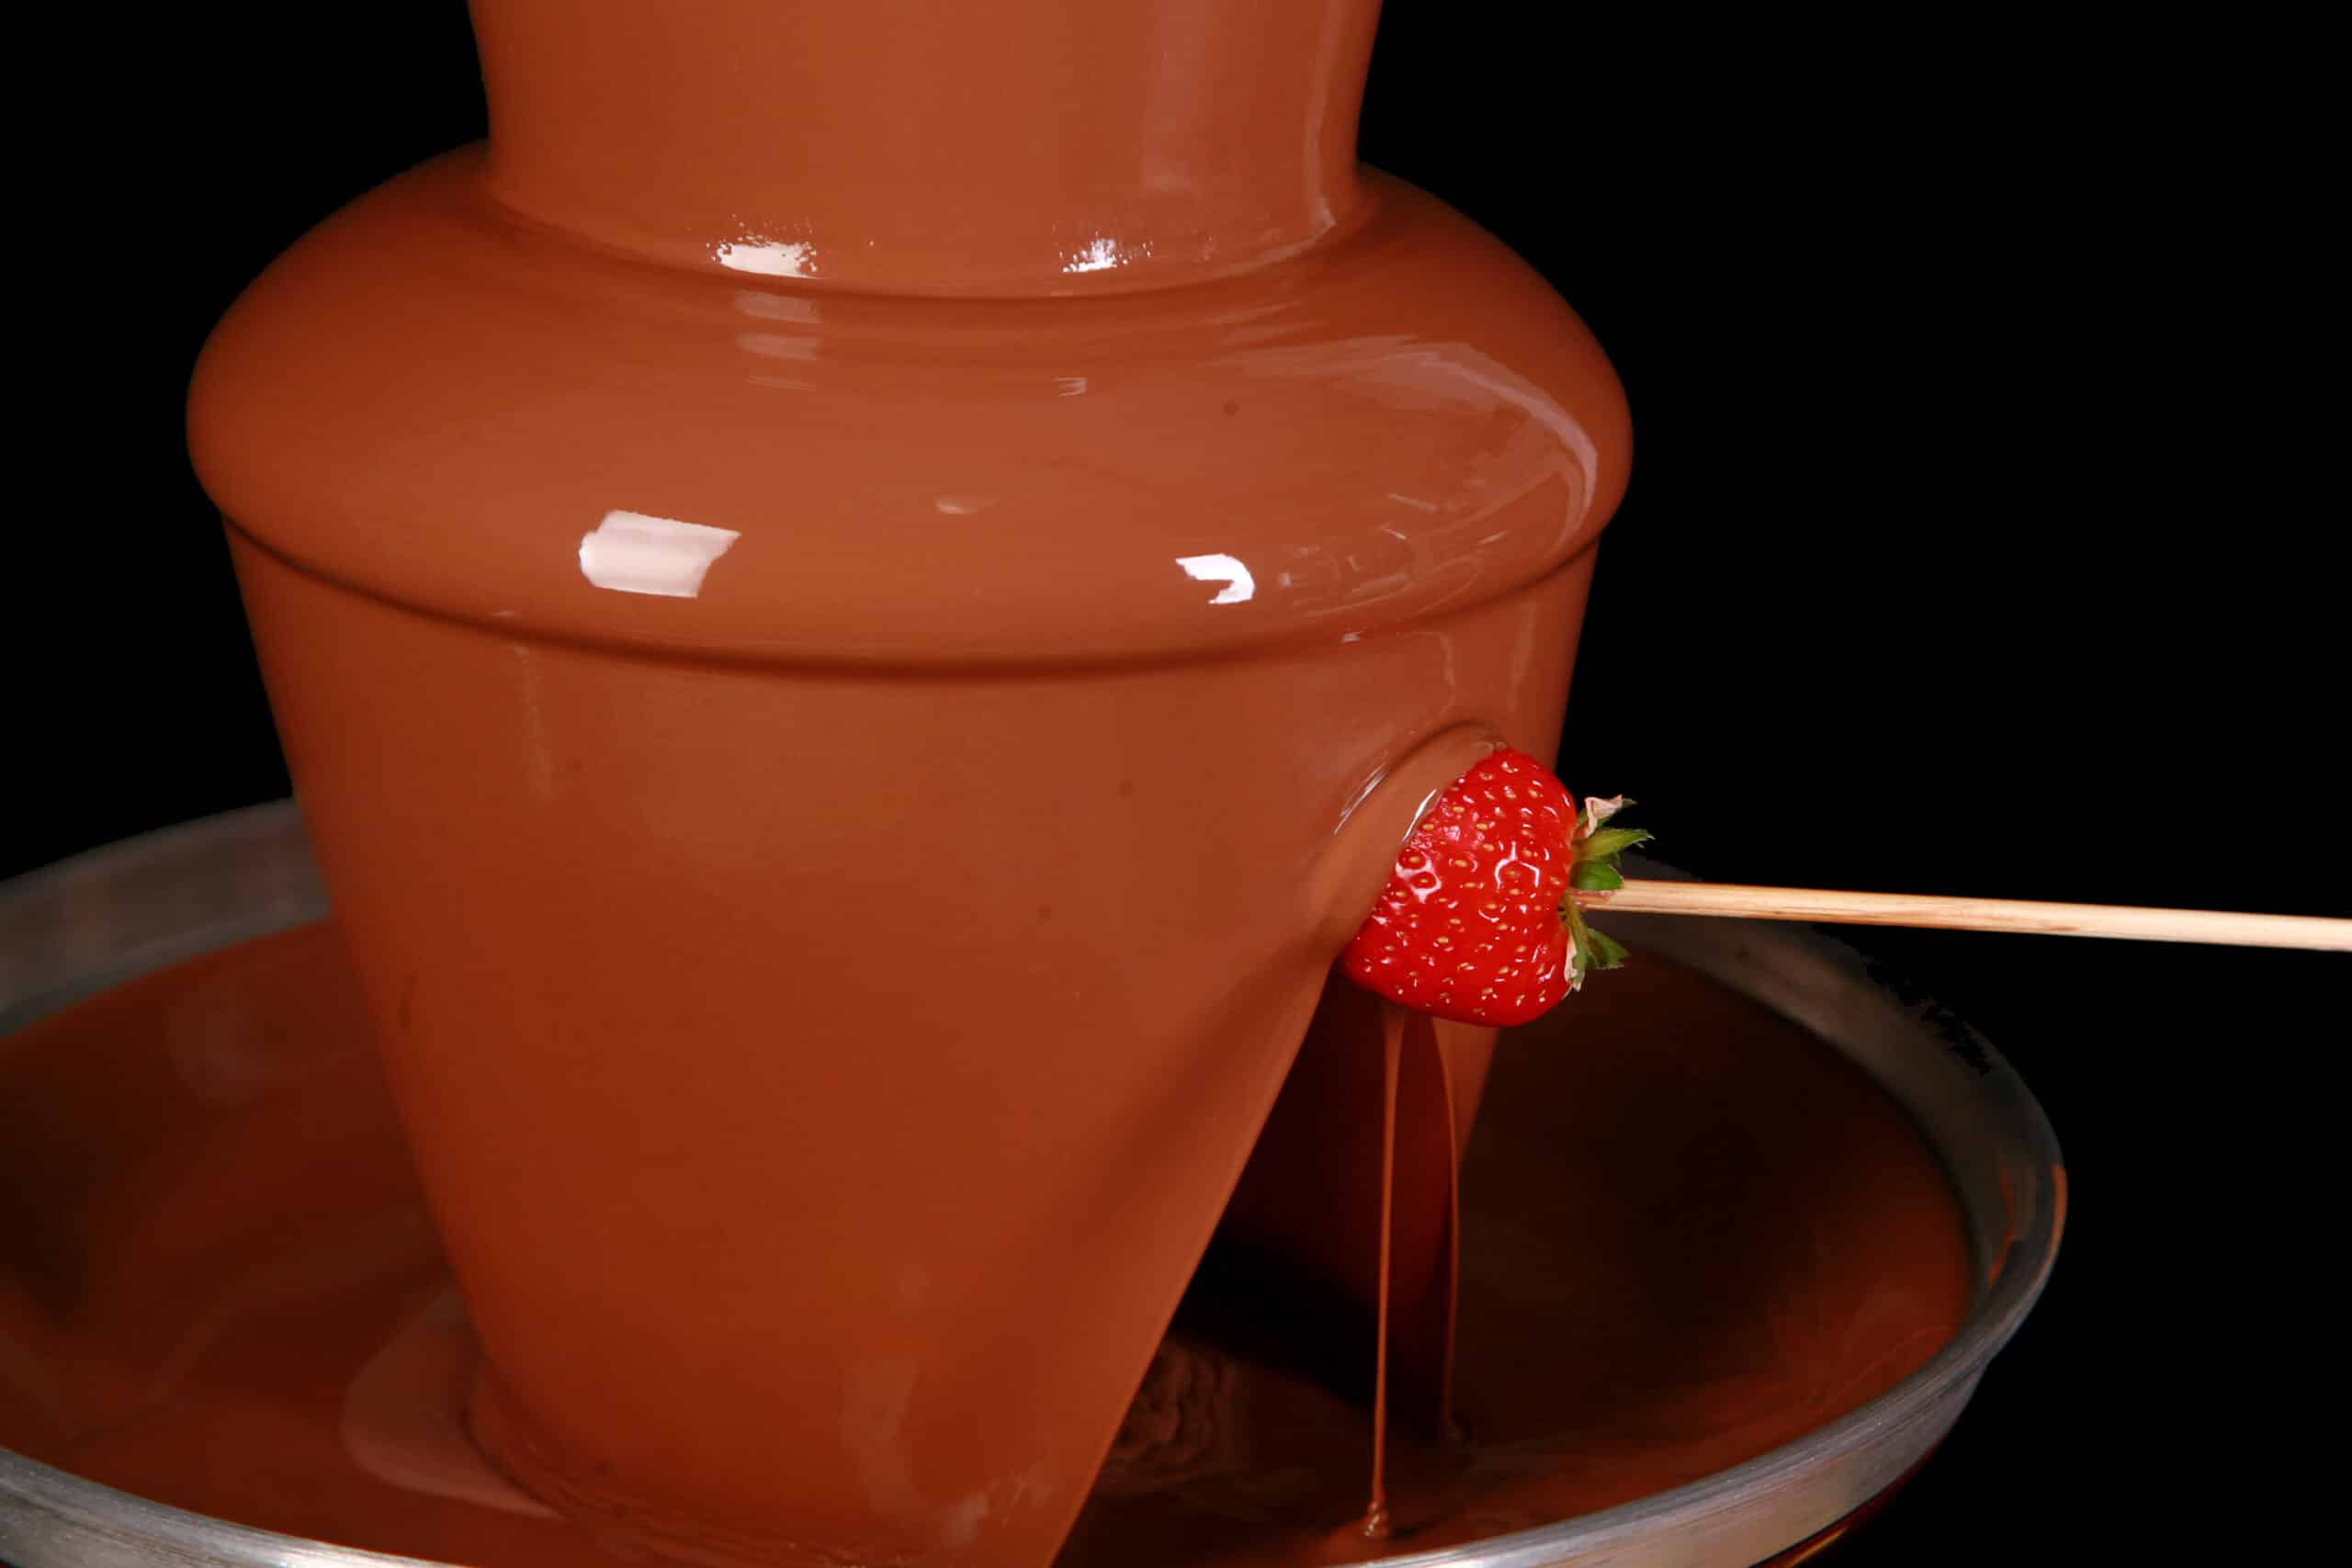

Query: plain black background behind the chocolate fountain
[0,0,2352,1568]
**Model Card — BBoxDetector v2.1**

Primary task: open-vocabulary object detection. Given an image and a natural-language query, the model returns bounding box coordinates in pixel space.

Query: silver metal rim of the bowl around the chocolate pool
[0,802,2065,1568]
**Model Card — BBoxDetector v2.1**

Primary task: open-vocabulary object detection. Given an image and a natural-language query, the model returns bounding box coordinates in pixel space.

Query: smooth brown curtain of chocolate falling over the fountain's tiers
[190,0,1628,1568]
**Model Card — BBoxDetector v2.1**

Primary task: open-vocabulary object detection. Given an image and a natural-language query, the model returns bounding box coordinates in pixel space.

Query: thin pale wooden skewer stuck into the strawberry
[1576,877,2352,952]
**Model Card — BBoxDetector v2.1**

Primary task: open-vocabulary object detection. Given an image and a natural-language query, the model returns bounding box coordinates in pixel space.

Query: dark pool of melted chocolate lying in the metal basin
[0,926,1973,1568]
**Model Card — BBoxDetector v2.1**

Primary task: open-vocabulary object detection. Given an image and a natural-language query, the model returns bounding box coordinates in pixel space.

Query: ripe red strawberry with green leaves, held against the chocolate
[1340,750,1649,1025]
